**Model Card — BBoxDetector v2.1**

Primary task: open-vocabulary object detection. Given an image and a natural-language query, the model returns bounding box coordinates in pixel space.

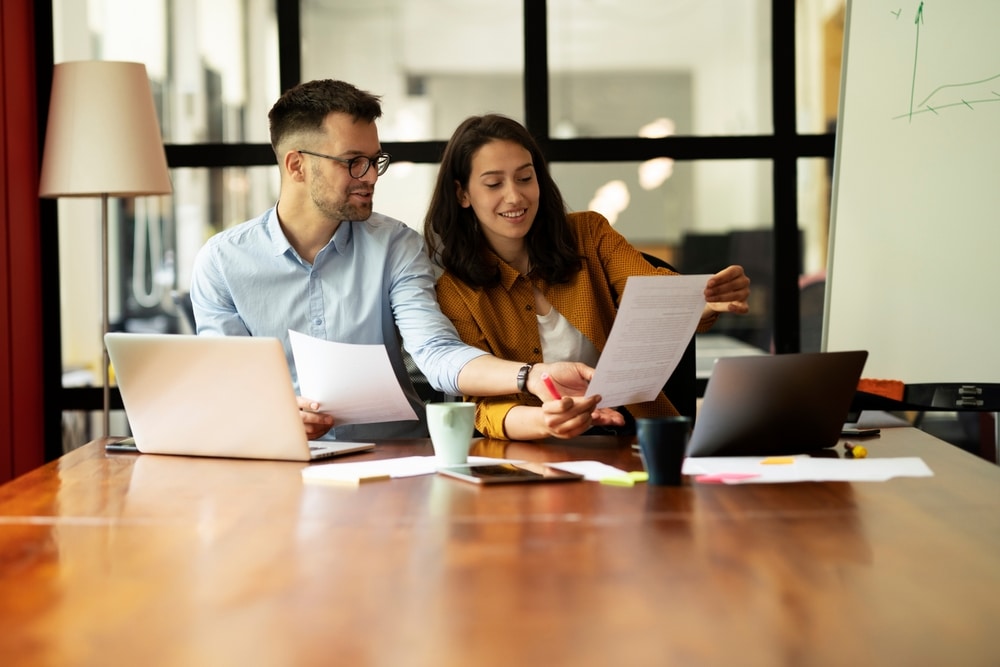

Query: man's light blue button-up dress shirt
[191,208,485,440]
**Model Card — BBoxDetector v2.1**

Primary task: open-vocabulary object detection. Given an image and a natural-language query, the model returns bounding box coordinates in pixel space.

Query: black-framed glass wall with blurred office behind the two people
[36,0,844,455]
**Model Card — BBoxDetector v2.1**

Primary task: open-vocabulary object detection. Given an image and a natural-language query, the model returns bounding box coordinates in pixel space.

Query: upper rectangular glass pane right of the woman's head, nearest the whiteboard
[547,0,772,137]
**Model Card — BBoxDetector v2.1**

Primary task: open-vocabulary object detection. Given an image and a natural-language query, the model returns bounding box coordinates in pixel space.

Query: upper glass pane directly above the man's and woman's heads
[301,0,524,141]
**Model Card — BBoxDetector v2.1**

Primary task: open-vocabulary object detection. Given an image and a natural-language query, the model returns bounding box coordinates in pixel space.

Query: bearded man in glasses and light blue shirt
[191,80,604,440]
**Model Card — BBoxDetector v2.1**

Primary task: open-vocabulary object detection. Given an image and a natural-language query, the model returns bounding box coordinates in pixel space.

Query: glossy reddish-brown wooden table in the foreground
[0,428,1000,667]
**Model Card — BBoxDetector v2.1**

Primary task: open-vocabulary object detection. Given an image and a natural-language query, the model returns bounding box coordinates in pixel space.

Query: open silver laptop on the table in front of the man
[104,332,375,461]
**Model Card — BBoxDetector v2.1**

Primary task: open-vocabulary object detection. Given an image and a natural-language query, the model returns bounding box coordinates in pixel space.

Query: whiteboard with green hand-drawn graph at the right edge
[823,0,1000,384]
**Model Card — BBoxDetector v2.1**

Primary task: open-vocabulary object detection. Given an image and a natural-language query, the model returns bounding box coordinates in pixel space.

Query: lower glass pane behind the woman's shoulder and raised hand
[552,160,774,350]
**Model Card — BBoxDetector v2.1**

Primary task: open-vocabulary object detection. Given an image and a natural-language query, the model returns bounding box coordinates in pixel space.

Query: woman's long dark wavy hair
[424,114,580,287]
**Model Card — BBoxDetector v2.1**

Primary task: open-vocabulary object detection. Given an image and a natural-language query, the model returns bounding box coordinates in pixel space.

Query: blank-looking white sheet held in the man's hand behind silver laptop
[288,329,418,426]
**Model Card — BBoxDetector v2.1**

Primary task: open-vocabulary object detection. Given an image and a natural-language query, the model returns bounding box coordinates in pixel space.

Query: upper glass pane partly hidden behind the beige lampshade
[52,0,280,144]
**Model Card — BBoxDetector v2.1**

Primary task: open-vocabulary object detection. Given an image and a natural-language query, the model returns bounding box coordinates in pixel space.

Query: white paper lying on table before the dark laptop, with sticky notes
[683,456,934,484]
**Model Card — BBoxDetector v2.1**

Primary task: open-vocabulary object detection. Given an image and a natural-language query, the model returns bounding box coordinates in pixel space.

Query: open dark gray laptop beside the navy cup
[687,351,868,456]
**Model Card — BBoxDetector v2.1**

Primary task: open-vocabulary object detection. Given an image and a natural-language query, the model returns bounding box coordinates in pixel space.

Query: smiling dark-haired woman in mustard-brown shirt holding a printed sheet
[424,115,750,440]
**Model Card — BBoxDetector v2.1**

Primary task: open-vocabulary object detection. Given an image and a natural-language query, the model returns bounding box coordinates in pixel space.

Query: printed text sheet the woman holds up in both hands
[587,275,711,408]
